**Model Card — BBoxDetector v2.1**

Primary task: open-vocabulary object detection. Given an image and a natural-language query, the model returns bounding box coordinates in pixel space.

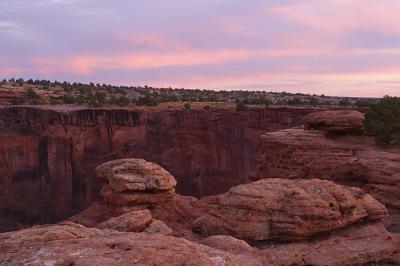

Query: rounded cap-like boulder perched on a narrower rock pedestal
[96,159,176,205]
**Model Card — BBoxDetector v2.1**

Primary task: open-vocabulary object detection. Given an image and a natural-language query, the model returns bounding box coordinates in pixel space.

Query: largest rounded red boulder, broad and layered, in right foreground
[193,179,387,240]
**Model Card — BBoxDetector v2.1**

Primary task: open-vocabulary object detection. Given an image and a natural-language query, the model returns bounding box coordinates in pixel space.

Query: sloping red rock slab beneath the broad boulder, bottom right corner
[259,223,400,266]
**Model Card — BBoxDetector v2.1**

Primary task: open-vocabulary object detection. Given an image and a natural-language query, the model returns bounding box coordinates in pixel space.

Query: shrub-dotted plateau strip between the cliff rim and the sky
[0,78,376,107]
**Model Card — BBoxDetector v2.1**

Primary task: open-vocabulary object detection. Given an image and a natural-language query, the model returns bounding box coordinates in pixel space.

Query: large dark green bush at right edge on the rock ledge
[364,96,400,144]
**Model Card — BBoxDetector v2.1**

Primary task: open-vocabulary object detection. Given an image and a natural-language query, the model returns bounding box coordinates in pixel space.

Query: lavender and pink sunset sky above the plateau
[0,0,400,97]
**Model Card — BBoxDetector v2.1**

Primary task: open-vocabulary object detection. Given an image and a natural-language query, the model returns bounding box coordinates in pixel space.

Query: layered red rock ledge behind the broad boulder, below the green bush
[252,129,400,231]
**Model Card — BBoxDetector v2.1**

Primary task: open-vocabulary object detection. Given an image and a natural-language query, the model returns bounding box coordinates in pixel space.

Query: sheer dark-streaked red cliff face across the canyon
[0,106,313,230]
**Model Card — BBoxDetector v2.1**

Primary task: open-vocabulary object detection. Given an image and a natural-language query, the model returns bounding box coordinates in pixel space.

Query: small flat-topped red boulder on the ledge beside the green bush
[304,110,364,134]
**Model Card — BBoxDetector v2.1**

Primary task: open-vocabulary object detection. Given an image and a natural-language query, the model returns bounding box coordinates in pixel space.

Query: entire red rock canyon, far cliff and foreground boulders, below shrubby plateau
[0,106,400,266]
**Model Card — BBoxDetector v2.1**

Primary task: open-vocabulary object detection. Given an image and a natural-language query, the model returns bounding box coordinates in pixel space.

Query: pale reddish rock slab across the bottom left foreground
[0,225,273,266]
